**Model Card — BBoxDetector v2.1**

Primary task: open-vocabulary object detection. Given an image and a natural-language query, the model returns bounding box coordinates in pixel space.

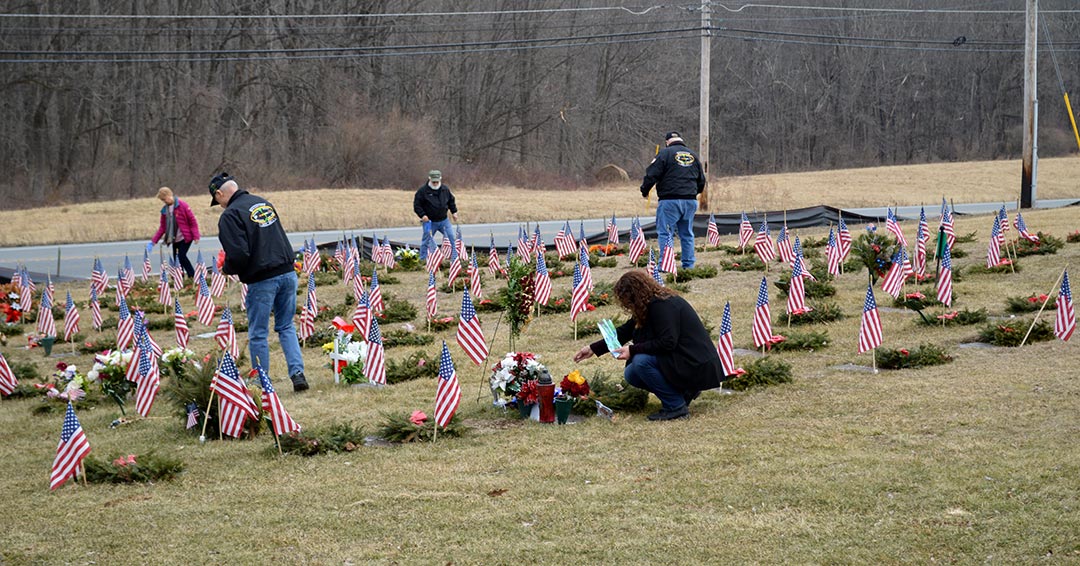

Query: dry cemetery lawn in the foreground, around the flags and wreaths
[0,176,1080,564]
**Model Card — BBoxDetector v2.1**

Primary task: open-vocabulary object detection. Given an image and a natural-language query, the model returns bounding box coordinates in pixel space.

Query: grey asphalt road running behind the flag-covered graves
[0,199,1080,279]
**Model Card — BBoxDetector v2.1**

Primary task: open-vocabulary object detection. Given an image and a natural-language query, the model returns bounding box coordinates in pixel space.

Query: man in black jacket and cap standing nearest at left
[210,173,308,392]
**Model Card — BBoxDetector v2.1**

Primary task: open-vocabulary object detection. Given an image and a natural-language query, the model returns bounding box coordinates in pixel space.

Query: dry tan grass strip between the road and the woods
[0,158,1080,246]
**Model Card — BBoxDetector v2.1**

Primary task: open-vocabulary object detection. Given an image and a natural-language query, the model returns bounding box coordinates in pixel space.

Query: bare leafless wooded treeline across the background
[0,0,1080,207]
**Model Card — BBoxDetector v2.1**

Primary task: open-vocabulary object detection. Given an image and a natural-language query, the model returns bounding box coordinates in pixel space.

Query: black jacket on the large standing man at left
[217,190,296,284]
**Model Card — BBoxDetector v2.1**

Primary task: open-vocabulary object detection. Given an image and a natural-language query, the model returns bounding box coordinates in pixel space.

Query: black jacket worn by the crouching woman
[589,296,724,393]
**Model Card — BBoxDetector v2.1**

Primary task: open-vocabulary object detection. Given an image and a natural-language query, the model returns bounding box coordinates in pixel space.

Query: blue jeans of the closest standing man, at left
[247,271,303,377]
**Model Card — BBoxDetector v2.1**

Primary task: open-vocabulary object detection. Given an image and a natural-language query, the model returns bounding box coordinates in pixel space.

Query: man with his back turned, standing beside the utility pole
[642,132,705,269]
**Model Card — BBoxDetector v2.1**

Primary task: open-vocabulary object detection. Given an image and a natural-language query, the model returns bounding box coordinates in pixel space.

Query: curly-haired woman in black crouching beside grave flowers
[573,269,724,420]
